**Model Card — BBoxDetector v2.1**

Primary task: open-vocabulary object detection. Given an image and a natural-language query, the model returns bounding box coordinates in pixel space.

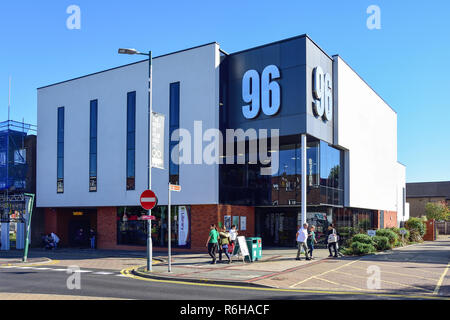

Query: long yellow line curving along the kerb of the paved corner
[120,267,450,301]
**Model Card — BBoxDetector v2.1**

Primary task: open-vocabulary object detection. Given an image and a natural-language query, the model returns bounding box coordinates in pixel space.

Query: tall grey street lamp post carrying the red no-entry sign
[119,49,153,272]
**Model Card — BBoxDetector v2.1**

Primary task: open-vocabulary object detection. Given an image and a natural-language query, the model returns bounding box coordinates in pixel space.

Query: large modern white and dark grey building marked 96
[37,35,408,249]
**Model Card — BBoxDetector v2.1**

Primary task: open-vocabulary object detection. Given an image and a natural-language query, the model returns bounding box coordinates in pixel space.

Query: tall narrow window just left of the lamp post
[127,91,136,190]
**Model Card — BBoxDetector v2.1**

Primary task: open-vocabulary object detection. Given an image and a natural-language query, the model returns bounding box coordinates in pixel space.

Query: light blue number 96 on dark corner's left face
[242,65,281,119]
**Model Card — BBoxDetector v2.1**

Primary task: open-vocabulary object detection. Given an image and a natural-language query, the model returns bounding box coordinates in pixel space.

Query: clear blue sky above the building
[0,0,450,182]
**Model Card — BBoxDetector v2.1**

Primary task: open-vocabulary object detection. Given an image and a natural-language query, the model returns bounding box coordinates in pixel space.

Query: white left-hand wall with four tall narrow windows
[36,44,220,207]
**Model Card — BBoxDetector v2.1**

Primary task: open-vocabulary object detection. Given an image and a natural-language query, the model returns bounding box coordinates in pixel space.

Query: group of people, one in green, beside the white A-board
[206,224,238,264]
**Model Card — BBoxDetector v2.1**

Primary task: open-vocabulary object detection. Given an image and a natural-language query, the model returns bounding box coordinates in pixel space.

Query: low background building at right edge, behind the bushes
[406,181,450,217]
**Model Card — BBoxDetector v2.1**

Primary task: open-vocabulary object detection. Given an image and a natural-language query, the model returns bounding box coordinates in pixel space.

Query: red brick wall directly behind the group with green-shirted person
[191,205,255,250]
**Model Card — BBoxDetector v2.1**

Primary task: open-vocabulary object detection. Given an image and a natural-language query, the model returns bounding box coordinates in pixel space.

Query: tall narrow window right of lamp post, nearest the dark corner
[169,82,180,184]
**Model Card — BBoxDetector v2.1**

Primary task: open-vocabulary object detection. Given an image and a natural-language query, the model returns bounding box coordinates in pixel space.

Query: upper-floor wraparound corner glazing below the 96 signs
[220,139,343,206]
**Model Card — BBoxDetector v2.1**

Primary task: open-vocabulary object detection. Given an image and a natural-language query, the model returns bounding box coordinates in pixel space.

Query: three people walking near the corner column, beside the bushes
[296,223,338,260]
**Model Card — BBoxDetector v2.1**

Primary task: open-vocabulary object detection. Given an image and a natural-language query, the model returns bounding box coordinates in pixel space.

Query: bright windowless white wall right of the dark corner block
[333,56,405,211]
